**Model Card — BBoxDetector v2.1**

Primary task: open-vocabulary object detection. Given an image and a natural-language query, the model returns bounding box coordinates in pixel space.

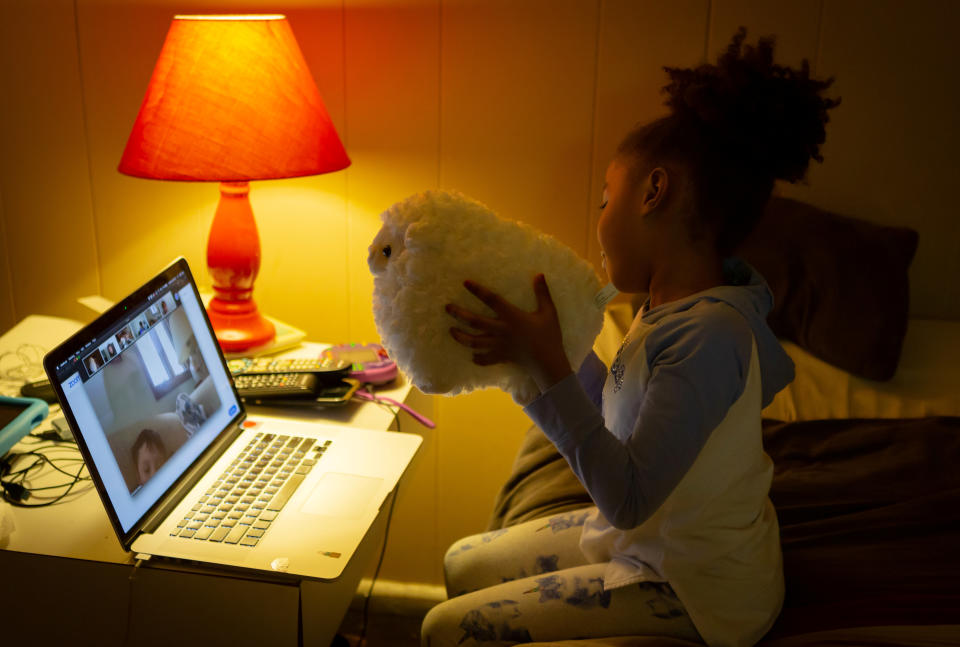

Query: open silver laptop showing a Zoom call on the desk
[43,258,421,580]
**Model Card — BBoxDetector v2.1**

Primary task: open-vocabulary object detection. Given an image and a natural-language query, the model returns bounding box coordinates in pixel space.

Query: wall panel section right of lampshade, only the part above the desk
[345,0,440,342]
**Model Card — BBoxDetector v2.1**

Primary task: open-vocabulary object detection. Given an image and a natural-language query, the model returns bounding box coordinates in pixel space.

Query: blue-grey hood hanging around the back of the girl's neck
[642,258,794,407]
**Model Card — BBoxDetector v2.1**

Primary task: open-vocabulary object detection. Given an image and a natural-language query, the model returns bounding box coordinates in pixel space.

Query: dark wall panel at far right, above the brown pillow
[801,0,960,319]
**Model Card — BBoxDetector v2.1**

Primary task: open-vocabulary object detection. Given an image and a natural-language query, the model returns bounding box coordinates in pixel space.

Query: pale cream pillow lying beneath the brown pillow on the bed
[763,319,960,421]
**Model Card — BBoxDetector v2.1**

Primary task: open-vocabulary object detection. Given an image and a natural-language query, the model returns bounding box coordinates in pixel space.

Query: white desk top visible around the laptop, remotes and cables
[0,315,411,563]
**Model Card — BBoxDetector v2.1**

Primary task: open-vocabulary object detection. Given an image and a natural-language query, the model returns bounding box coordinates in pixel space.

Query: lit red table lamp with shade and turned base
[119,15,350,352]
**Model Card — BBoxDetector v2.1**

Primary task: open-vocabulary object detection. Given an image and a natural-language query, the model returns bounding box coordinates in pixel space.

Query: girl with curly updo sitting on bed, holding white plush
[422,29,837,647]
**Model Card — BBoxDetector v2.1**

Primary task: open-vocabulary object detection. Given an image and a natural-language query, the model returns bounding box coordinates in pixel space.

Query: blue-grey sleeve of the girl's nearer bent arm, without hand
[524,309,753,529]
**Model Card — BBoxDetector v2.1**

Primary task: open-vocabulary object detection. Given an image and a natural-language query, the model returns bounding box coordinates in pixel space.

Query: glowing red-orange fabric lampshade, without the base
[120,15,350,181]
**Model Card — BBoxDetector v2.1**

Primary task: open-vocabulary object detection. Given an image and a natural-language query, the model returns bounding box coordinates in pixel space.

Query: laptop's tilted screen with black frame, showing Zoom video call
[45,259,242,535]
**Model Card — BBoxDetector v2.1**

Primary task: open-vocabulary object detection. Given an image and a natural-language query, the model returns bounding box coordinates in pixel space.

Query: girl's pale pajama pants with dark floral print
[421,509,701,647]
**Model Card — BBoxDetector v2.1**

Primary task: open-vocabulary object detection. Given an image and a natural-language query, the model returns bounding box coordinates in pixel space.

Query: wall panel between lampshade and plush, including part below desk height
[342,0,445,584]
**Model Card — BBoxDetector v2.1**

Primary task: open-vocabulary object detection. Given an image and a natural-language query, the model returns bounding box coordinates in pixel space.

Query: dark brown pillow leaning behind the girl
[737,197,918,380]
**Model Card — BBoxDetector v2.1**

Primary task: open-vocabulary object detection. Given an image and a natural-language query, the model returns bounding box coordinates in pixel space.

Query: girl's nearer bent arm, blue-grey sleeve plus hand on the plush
[447,277,753,529]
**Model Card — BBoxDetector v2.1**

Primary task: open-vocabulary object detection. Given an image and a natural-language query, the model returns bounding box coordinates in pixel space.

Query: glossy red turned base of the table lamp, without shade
[207,182,276,353]
